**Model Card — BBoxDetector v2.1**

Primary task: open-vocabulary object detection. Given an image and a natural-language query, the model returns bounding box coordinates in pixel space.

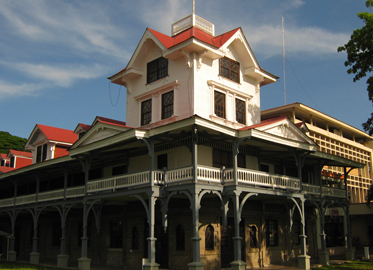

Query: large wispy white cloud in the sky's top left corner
[0,0,126,59]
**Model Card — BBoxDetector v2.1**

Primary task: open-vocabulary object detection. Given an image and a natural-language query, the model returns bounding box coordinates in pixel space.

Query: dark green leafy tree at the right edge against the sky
[338,0,373,135]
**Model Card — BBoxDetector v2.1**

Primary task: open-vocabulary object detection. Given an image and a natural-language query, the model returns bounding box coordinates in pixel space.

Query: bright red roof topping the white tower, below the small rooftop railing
[148,27,240,49]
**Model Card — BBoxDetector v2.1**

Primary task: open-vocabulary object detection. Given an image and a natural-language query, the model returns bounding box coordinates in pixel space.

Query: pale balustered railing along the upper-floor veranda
[0,166,346,208]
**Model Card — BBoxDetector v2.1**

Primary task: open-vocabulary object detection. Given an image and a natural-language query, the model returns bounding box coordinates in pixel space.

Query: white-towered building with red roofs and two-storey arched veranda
[0,14,364,270]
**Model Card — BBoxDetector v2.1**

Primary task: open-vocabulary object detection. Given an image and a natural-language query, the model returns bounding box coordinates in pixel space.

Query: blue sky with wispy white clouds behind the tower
[0,0,373,138]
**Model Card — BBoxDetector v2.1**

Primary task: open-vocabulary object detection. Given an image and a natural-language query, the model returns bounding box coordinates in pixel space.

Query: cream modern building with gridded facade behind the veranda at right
[262,103,373,254]
